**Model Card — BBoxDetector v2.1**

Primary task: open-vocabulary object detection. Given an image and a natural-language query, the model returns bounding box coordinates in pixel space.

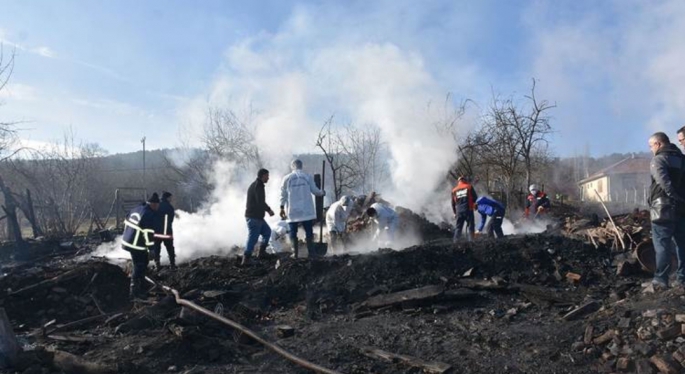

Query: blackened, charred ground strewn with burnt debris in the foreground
[0,215,685,374]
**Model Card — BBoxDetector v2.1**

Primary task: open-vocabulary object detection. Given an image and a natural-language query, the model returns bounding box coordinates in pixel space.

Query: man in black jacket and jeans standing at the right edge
[649,132,685,287]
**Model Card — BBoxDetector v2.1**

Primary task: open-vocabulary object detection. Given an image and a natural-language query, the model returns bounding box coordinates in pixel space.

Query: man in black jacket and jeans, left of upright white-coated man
[242,169,274,265]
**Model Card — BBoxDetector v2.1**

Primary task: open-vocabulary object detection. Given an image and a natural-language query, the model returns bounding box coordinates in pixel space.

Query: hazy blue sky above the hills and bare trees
[0,0,685,156]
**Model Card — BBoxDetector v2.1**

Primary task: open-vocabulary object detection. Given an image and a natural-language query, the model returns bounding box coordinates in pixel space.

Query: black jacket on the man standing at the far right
[649,144,685,214]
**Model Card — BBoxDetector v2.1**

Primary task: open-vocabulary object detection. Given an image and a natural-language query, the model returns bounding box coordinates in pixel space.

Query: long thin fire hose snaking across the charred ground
[145,277,341,374]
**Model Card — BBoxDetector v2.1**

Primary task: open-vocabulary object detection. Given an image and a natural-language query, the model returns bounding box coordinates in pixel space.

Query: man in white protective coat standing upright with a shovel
[280,160,325,257]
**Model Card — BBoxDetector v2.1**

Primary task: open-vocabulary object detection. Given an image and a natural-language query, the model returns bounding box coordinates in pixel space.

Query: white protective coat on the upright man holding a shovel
[281,169,324,223]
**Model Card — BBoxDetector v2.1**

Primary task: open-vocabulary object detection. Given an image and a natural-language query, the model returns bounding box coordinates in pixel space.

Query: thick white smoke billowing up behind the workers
[95,9,476,261]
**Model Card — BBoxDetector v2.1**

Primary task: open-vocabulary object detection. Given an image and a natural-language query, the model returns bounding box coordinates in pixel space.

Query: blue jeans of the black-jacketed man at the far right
[652,219,685,285]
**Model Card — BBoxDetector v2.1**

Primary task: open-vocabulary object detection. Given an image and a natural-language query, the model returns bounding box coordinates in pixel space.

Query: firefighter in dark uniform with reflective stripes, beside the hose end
[121,193,159,298]
